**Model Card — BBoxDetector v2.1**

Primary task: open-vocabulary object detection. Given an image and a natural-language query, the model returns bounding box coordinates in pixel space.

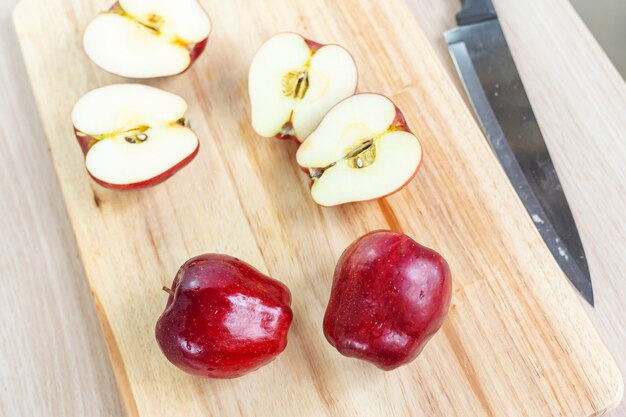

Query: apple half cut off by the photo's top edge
[83,0,211,78]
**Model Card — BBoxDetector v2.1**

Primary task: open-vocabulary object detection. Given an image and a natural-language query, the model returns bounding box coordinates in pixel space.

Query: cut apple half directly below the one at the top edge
[72,84,199,190]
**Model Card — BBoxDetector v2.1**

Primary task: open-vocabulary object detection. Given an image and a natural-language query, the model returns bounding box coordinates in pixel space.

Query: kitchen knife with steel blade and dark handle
[444,0,594,306]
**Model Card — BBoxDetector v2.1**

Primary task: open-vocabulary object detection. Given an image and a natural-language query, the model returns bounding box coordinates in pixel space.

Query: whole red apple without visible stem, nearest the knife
[324,230,452,371]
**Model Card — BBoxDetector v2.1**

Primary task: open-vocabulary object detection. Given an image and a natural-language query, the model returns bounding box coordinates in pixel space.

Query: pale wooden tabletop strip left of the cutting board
[0,0,123,417]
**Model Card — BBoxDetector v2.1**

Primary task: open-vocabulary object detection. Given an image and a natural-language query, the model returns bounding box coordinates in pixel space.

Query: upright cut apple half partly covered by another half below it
[248,33,358,142]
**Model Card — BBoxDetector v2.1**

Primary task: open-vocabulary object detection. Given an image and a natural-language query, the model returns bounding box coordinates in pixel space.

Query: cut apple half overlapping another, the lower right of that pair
[296,93,422,206]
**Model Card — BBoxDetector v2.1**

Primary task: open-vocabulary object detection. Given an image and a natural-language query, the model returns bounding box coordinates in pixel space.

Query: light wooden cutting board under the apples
[14,0,623,417]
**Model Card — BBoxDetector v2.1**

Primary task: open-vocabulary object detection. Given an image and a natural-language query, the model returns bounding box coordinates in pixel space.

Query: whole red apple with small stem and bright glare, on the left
[155,254,293,378]
